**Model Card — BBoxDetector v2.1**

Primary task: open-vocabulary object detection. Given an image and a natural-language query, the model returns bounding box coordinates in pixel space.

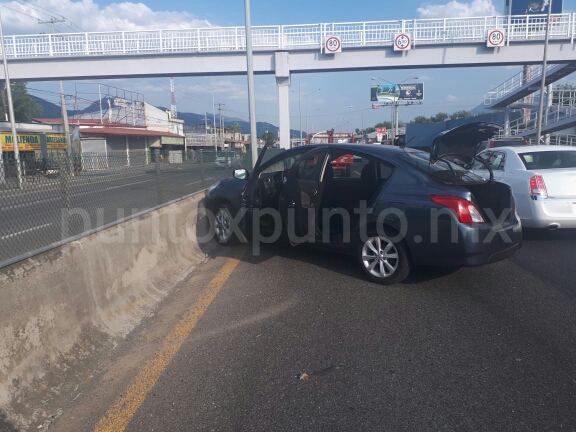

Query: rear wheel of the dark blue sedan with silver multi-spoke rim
[357,233,410,285]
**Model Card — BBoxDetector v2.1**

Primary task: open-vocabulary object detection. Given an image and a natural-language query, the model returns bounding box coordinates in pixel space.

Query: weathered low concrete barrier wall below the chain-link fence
[0,193,205,429]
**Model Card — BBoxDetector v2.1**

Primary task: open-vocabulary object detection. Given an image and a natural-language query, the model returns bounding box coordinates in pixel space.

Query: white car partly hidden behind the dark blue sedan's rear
[472,145,576,230]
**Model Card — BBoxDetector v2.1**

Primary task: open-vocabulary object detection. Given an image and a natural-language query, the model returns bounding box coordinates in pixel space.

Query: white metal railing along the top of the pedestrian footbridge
[4,13,576,58]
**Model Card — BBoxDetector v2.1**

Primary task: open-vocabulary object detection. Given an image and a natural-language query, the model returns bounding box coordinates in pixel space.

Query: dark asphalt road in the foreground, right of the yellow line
[98,231,576,432]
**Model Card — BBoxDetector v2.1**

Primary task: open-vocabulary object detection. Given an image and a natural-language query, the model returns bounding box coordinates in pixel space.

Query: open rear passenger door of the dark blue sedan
[278,148,327,245]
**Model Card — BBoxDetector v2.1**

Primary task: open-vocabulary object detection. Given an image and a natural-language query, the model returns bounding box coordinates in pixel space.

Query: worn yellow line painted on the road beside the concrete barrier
[94,248,245,432]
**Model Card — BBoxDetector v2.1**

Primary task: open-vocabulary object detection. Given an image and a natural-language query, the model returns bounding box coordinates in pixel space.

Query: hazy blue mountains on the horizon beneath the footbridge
[30,95,306,136]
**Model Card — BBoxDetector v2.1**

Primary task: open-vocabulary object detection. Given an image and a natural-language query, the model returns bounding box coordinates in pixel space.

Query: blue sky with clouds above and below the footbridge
[0,0,576,130]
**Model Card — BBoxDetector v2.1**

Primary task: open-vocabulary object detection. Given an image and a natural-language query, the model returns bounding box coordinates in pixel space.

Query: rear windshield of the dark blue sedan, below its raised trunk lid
[400,150,486,184]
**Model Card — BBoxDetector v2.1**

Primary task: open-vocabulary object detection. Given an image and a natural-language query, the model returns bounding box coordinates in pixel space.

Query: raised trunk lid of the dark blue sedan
[430,122,502,165]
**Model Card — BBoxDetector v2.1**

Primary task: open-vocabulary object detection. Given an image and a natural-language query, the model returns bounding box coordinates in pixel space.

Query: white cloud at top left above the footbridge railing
[0,0,211,35]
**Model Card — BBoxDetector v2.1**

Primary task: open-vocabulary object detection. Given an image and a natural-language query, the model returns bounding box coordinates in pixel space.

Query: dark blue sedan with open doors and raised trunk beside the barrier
[206,139,522,285]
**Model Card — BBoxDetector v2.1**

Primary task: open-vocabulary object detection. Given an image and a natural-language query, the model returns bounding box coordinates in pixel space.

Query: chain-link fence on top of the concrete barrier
[0,150,241,267]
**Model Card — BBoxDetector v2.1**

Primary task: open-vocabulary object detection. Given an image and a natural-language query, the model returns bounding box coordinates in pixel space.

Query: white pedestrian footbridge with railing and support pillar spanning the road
[4,13,576,146]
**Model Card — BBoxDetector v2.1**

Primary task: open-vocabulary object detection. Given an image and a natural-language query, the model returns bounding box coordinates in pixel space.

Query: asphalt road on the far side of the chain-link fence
[0,164,231,262]
